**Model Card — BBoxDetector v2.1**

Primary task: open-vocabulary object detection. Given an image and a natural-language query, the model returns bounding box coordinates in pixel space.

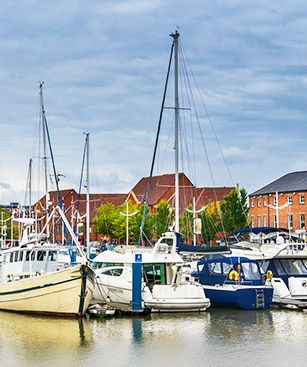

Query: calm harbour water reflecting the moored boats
[0,309,307,367]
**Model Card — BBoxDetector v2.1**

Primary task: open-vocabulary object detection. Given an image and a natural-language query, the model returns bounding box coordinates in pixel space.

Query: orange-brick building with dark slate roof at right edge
[249,171,307,231]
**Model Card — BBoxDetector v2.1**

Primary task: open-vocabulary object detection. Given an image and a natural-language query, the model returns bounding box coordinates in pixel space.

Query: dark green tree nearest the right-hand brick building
[221,188,249,234]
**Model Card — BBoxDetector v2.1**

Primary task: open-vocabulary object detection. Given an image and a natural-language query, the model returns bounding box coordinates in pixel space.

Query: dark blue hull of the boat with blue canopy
[204,287,273,310]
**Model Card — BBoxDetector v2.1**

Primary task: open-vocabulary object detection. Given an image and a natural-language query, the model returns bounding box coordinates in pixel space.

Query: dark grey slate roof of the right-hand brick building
[249,171,307,196]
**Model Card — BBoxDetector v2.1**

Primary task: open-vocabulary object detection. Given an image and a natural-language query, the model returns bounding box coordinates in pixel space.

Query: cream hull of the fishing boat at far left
[0,265,94,317]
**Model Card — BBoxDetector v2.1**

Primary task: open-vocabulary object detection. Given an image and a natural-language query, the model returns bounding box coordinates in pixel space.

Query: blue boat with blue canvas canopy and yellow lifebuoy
[194,256,273,310]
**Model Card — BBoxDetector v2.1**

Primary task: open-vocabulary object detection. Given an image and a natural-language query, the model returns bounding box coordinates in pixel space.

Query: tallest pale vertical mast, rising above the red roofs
[171,31,180,232]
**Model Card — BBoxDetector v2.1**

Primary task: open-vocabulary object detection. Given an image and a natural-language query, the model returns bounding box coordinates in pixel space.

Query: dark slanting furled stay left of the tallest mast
[138,32,174,246]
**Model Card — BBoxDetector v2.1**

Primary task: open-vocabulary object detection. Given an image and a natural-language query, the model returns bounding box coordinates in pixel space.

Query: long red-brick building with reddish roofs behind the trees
[32,173,233,241]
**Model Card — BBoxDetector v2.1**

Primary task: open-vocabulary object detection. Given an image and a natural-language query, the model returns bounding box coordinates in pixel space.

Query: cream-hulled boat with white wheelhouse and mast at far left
[0,83,95,317]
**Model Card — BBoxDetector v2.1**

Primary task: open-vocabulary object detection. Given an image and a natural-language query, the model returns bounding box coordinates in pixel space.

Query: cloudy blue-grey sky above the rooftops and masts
[0,0,307,204]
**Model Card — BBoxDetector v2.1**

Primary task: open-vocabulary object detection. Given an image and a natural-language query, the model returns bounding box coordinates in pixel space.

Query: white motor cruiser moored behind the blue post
[92,232,210,312]
